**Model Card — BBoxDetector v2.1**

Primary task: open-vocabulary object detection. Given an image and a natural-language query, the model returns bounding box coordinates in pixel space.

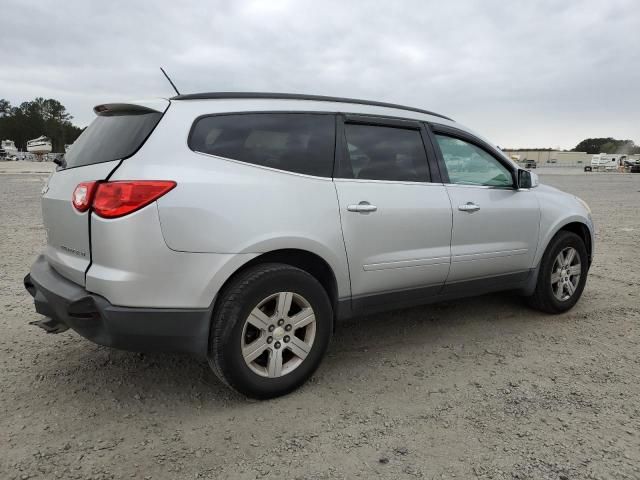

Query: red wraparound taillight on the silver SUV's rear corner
[73,180,176,218]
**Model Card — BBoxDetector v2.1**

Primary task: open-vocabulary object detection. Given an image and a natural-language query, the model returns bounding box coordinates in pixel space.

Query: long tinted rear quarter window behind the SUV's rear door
[189,113,335,177]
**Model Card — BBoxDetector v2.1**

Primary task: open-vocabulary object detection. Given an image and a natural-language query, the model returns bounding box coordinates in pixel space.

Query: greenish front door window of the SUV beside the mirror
[436,135,513,187]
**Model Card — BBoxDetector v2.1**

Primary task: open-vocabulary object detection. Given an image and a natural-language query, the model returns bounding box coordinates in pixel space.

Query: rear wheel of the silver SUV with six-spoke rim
[208,263,333,399]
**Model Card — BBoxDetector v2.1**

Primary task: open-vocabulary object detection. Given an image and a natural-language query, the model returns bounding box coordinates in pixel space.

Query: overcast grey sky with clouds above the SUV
[0,0,640,148]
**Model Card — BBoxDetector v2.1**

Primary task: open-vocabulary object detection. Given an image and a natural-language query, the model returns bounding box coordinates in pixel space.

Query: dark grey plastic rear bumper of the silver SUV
[24,255,211,356]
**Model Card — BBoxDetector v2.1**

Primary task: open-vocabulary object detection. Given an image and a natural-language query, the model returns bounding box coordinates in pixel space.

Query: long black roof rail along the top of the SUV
[171,92,453,121]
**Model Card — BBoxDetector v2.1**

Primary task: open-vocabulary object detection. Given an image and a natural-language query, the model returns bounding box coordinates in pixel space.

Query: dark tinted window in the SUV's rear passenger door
[342,124,429,182]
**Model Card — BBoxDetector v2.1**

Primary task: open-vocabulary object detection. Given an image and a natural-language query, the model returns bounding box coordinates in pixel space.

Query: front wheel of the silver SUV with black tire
[528,231,589,314]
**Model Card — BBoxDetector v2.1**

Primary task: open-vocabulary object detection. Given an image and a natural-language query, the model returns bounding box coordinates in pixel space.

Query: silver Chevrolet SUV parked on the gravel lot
[24,93,594,398]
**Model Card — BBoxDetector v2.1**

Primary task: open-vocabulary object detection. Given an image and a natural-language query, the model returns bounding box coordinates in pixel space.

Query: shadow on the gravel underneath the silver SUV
[30,294,549,407]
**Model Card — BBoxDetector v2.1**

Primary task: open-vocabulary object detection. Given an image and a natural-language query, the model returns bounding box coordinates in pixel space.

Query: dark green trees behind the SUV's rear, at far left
[0,97,82,152]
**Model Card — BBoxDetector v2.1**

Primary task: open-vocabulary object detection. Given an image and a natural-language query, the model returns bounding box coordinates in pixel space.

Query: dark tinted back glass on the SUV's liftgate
[64,112,162,168]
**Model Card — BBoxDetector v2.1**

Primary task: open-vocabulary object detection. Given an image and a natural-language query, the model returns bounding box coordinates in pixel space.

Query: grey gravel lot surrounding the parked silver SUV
[0,163,640,480]
